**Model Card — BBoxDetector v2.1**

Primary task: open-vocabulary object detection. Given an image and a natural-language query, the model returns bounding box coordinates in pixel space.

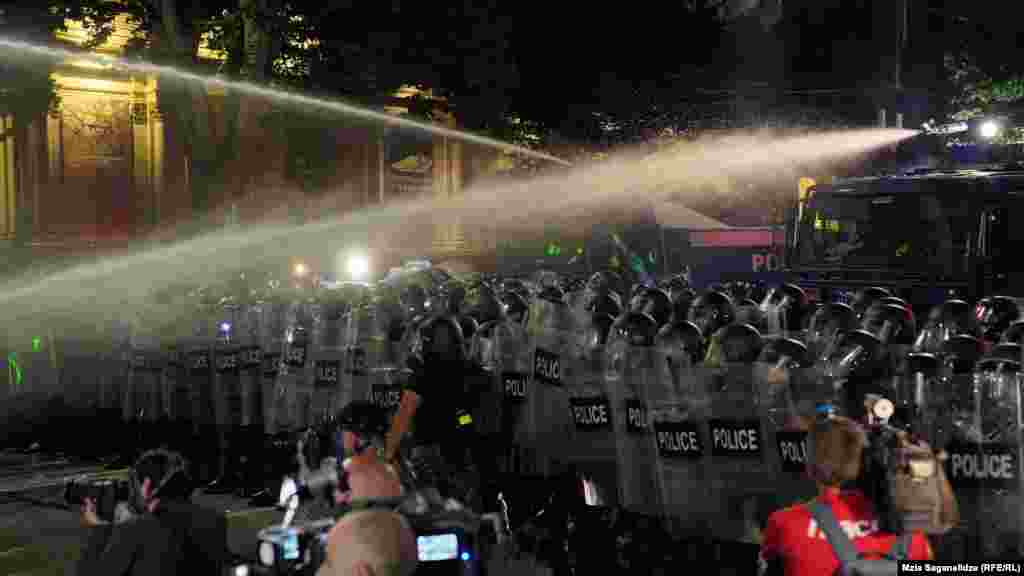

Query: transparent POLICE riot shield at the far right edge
[946,358,1024,558]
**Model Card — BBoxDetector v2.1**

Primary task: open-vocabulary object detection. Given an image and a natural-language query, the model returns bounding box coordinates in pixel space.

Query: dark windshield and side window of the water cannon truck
[795,193,970,274]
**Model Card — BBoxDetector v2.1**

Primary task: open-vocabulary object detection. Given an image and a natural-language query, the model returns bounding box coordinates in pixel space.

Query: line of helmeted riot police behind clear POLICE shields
[12,262,1024,565]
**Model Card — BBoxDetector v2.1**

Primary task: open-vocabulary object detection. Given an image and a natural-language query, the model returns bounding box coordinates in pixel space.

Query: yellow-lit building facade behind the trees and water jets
[0,11,478,266]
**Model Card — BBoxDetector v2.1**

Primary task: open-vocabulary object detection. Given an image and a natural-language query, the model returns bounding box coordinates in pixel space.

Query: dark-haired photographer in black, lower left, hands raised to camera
[77,450,228,576]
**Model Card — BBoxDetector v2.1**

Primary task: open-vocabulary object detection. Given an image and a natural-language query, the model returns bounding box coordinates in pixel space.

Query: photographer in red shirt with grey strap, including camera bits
[759,414,937,576]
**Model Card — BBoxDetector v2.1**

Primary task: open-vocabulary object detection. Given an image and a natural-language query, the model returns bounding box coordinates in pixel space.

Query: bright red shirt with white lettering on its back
[759,490,933,576]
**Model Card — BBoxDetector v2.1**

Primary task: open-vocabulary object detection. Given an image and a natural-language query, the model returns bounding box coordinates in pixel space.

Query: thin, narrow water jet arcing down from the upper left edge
[0,38,571,166]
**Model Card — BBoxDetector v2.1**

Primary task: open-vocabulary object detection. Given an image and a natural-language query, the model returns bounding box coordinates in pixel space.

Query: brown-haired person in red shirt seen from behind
[759,416,933,576]
